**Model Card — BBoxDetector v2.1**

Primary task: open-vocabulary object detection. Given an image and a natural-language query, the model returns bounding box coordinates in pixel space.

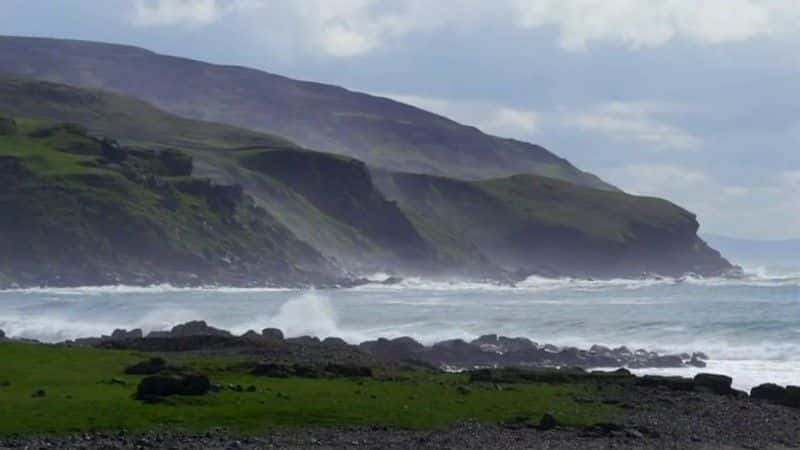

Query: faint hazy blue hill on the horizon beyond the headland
[703,234,800,267]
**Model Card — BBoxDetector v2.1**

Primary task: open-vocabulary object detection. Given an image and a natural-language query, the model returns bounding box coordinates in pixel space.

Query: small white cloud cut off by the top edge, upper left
[131,0,224,26]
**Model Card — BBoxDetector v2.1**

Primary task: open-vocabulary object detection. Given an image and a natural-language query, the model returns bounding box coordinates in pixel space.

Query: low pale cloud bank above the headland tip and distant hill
[599,164,800,239]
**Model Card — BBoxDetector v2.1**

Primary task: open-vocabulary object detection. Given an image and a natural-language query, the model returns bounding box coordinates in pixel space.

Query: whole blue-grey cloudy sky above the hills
[0,0,800,239]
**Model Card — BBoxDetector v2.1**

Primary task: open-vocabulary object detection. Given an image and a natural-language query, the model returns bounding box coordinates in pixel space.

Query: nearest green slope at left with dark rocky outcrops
[0,114,333,285]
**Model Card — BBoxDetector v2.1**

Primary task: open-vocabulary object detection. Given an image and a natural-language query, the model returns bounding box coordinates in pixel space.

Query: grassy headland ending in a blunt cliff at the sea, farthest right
[376,172,731,277]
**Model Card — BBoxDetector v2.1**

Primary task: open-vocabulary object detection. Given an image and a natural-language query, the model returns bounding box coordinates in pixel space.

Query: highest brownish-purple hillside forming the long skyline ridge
[0,37,611,188]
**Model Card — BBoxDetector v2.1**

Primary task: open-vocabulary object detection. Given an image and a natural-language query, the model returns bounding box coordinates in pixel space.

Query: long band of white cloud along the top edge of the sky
[125,0,800,57]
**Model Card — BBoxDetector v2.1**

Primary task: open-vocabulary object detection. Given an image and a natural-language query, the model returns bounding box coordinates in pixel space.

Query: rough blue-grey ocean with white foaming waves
[0,270,800,389]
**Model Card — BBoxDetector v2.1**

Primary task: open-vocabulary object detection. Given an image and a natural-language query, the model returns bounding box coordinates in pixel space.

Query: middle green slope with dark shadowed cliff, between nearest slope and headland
[0,76,444,272]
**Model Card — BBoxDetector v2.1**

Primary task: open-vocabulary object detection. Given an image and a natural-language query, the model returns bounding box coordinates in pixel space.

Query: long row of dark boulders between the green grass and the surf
[65,321,708,370]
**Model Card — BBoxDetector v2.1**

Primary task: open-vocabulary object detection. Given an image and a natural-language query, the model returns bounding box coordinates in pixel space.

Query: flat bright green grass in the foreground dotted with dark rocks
[0,342,616,436]
